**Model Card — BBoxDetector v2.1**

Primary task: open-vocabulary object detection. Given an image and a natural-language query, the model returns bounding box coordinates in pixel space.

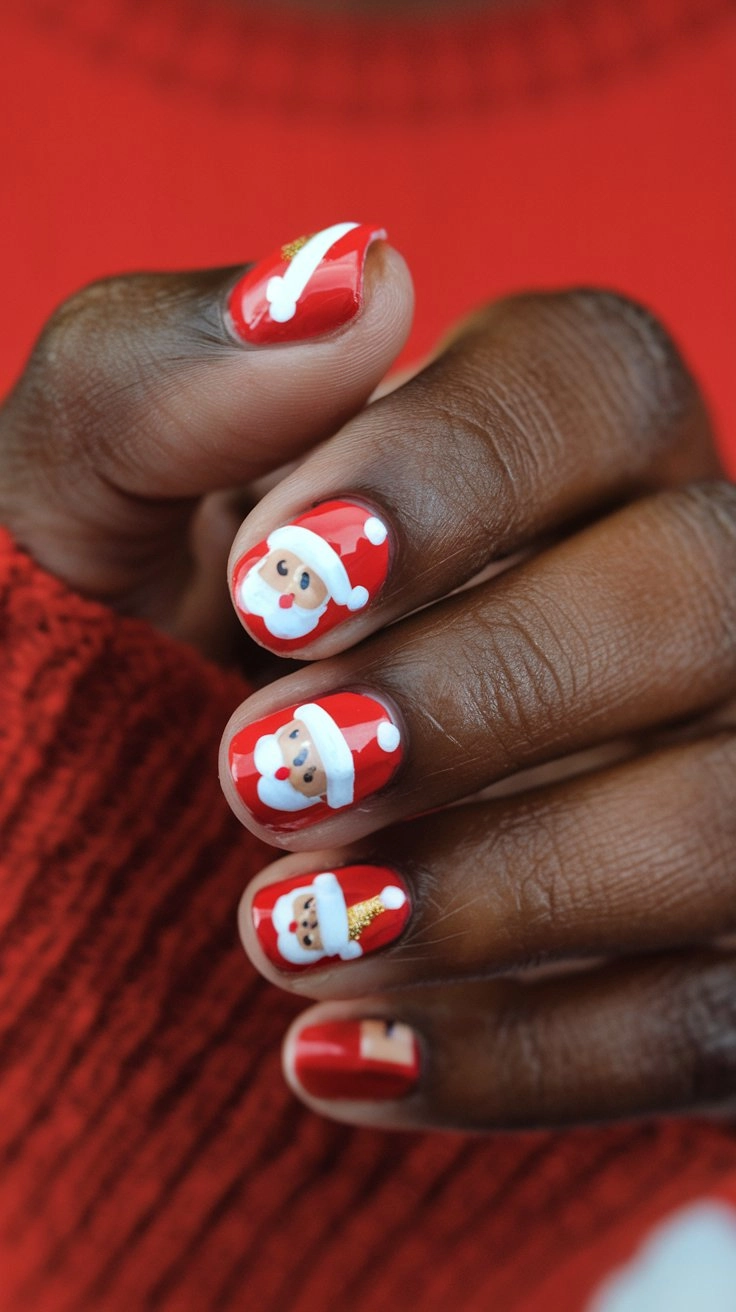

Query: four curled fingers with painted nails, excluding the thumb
[222,291,736,1128]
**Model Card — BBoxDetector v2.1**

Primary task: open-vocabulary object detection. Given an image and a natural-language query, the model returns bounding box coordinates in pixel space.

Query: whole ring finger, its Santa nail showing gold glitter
[239,733,736,998]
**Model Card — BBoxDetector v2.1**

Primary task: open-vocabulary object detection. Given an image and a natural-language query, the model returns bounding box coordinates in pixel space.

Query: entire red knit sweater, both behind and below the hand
[0,0,736,1312]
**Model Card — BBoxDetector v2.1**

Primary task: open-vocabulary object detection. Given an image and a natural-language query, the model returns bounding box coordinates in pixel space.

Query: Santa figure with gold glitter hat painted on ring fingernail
[272,871,407,966]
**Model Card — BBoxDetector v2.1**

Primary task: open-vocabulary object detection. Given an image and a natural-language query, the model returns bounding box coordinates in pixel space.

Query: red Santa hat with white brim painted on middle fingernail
[294,694,401,811]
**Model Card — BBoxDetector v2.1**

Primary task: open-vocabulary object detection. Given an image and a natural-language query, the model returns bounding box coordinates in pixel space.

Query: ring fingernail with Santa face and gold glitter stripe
[251,866,411,972]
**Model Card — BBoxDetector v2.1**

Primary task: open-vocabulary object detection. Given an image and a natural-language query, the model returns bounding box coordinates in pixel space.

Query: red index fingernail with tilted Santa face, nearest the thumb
[232,501,390,652]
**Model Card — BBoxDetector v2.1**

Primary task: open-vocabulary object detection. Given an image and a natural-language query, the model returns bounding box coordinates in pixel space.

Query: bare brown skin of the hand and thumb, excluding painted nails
[0,238,736,1130]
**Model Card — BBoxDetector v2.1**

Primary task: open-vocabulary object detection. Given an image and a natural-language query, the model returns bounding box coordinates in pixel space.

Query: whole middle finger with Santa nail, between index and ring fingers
[220,484,736,850]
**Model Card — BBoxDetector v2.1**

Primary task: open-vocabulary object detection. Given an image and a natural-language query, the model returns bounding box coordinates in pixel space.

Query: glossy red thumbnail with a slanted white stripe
[227,223,386,345]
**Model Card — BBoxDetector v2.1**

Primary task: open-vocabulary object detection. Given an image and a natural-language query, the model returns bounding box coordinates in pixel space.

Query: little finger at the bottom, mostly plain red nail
[283,953,736,1130]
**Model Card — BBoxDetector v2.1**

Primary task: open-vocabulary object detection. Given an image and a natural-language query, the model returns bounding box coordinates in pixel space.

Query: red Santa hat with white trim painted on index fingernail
[266,502,388,610]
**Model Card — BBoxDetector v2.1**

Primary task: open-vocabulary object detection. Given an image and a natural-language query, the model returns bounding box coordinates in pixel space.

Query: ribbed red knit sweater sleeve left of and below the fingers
[0,531,736,1312]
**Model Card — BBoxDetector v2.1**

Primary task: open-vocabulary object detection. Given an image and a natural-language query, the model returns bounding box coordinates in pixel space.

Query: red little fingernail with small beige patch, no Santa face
[293,1019,420,1101]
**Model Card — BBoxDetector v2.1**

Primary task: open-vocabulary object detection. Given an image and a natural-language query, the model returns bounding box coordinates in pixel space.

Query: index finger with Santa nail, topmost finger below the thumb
[230,291,718,659]
